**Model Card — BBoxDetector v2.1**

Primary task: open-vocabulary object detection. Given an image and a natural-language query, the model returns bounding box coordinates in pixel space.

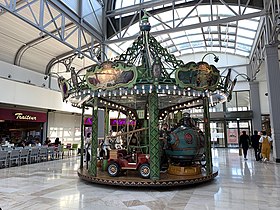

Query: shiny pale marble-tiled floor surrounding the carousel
[0,149,280,210]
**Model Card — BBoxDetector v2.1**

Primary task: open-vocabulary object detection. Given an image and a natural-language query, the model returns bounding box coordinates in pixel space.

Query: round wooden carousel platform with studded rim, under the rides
[78,167,218,187]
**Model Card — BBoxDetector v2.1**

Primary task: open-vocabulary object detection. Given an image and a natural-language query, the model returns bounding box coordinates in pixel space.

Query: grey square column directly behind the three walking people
[250,81,262,131]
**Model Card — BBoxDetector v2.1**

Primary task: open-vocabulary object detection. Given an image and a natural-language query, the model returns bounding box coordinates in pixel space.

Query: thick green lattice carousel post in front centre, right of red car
[149,92,160,181]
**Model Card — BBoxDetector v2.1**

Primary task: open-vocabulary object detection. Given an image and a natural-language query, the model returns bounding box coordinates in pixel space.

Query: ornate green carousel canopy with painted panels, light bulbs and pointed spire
[58,15,236,118]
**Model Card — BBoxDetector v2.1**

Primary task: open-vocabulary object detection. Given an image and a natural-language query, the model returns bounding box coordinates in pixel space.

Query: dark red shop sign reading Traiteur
[0,109,47,122]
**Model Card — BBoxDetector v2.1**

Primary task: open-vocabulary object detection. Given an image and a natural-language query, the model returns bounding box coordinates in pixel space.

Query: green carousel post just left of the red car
[89,98,98,176]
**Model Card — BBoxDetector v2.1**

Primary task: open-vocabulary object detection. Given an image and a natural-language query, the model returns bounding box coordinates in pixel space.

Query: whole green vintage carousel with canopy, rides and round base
[55,15,236,186]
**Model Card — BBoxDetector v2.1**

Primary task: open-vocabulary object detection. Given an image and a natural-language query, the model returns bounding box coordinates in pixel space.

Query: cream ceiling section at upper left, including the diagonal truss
[0,0,102,73]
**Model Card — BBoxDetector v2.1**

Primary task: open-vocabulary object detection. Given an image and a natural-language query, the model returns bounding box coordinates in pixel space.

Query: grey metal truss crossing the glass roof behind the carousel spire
[105,0,265,44]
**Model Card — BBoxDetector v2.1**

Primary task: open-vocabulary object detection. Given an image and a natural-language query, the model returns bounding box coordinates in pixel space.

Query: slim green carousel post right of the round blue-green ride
[203,97,213,175]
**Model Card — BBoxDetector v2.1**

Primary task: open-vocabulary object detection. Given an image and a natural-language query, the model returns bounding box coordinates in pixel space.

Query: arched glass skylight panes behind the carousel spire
[109,0,260,56]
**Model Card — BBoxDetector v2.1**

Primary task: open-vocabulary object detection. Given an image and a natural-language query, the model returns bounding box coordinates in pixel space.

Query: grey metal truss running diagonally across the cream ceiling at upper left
[0,0,103,62]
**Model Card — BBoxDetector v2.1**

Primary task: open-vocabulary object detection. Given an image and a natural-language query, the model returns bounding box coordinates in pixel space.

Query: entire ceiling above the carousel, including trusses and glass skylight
[0,0,279,81]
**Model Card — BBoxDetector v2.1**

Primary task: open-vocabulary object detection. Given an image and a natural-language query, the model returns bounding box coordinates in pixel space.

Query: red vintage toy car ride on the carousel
[107,150,151,178]
